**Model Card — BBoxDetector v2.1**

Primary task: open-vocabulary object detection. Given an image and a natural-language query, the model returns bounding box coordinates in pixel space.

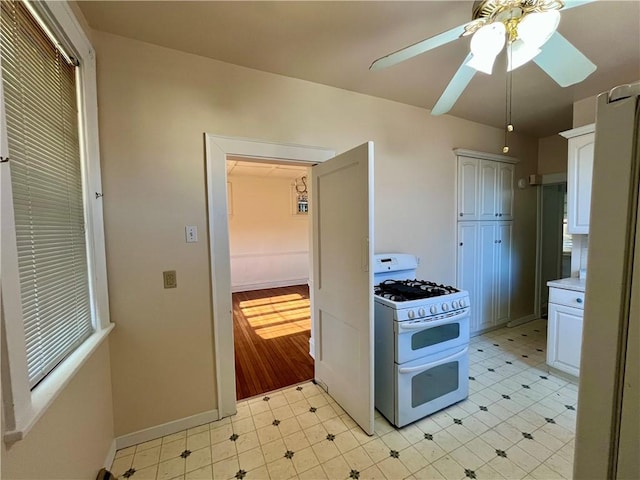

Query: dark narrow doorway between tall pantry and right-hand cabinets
[539,182,572,318]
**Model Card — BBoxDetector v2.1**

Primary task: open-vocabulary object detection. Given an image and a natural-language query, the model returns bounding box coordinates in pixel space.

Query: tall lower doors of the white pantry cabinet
[457,221,512,333]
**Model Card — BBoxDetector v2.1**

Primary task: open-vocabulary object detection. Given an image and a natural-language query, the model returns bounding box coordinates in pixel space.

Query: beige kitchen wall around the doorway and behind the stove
[93,32,538,435]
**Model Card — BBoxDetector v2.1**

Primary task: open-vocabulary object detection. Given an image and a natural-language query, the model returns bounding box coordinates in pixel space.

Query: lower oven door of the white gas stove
[395,346,469,427]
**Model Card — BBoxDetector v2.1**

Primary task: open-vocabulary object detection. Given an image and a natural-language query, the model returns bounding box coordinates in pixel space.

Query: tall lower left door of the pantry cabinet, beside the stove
[456,222,480,331]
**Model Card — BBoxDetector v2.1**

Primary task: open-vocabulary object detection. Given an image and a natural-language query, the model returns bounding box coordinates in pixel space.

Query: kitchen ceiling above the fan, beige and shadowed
[78,0,640,137]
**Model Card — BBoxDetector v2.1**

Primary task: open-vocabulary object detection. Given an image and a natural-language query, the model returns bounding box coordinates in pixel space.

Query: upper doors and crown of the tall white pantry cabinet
[455,149,517,221]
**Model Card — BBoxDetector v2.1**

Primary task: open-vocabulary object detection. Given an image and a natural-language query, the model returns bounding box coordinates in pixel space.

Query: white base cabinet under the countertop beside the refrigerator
[547,287,584,377]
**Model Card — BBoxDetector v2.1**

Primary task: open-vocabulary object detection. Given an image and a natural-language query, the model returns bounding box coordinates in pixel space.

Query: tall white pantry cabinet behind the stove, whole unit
[454,149,517,333]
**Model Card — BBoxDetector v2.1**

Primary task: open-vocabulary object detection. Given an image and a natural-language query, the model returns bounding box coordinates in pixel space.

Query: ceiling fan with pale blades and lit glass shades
[369,0,596,115]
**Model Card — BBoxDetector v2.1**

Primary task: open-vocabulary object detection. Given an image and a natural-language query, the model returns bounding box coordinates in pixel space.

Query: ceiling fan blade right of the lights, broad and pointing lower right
[533,32,597,87]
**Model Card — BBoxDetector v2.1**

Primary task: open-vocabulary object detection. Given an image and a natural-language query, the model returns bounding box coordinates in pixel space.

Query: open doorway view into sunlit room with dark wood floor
[227,156,314,400]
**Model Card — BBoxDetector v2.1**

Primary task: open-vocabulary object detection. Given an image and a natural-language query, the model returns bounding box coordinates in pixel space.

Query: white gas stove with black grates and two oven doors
[374,254,470,427]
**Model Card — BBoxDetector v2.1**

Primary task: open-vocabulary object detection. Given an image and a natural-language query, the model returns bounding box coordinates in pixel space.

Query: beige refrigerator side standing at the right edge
[574,83,640,480]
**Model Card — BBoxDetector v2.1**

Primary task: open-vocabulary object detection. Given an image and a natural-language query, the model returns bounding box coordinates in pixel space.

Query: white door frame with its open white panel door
[205,134,374,435]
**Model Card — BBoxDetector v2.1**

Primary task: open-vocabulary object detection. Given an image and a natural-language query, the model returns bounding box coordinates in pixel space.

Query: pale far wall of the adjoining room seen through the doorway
[228,175,309,292]
